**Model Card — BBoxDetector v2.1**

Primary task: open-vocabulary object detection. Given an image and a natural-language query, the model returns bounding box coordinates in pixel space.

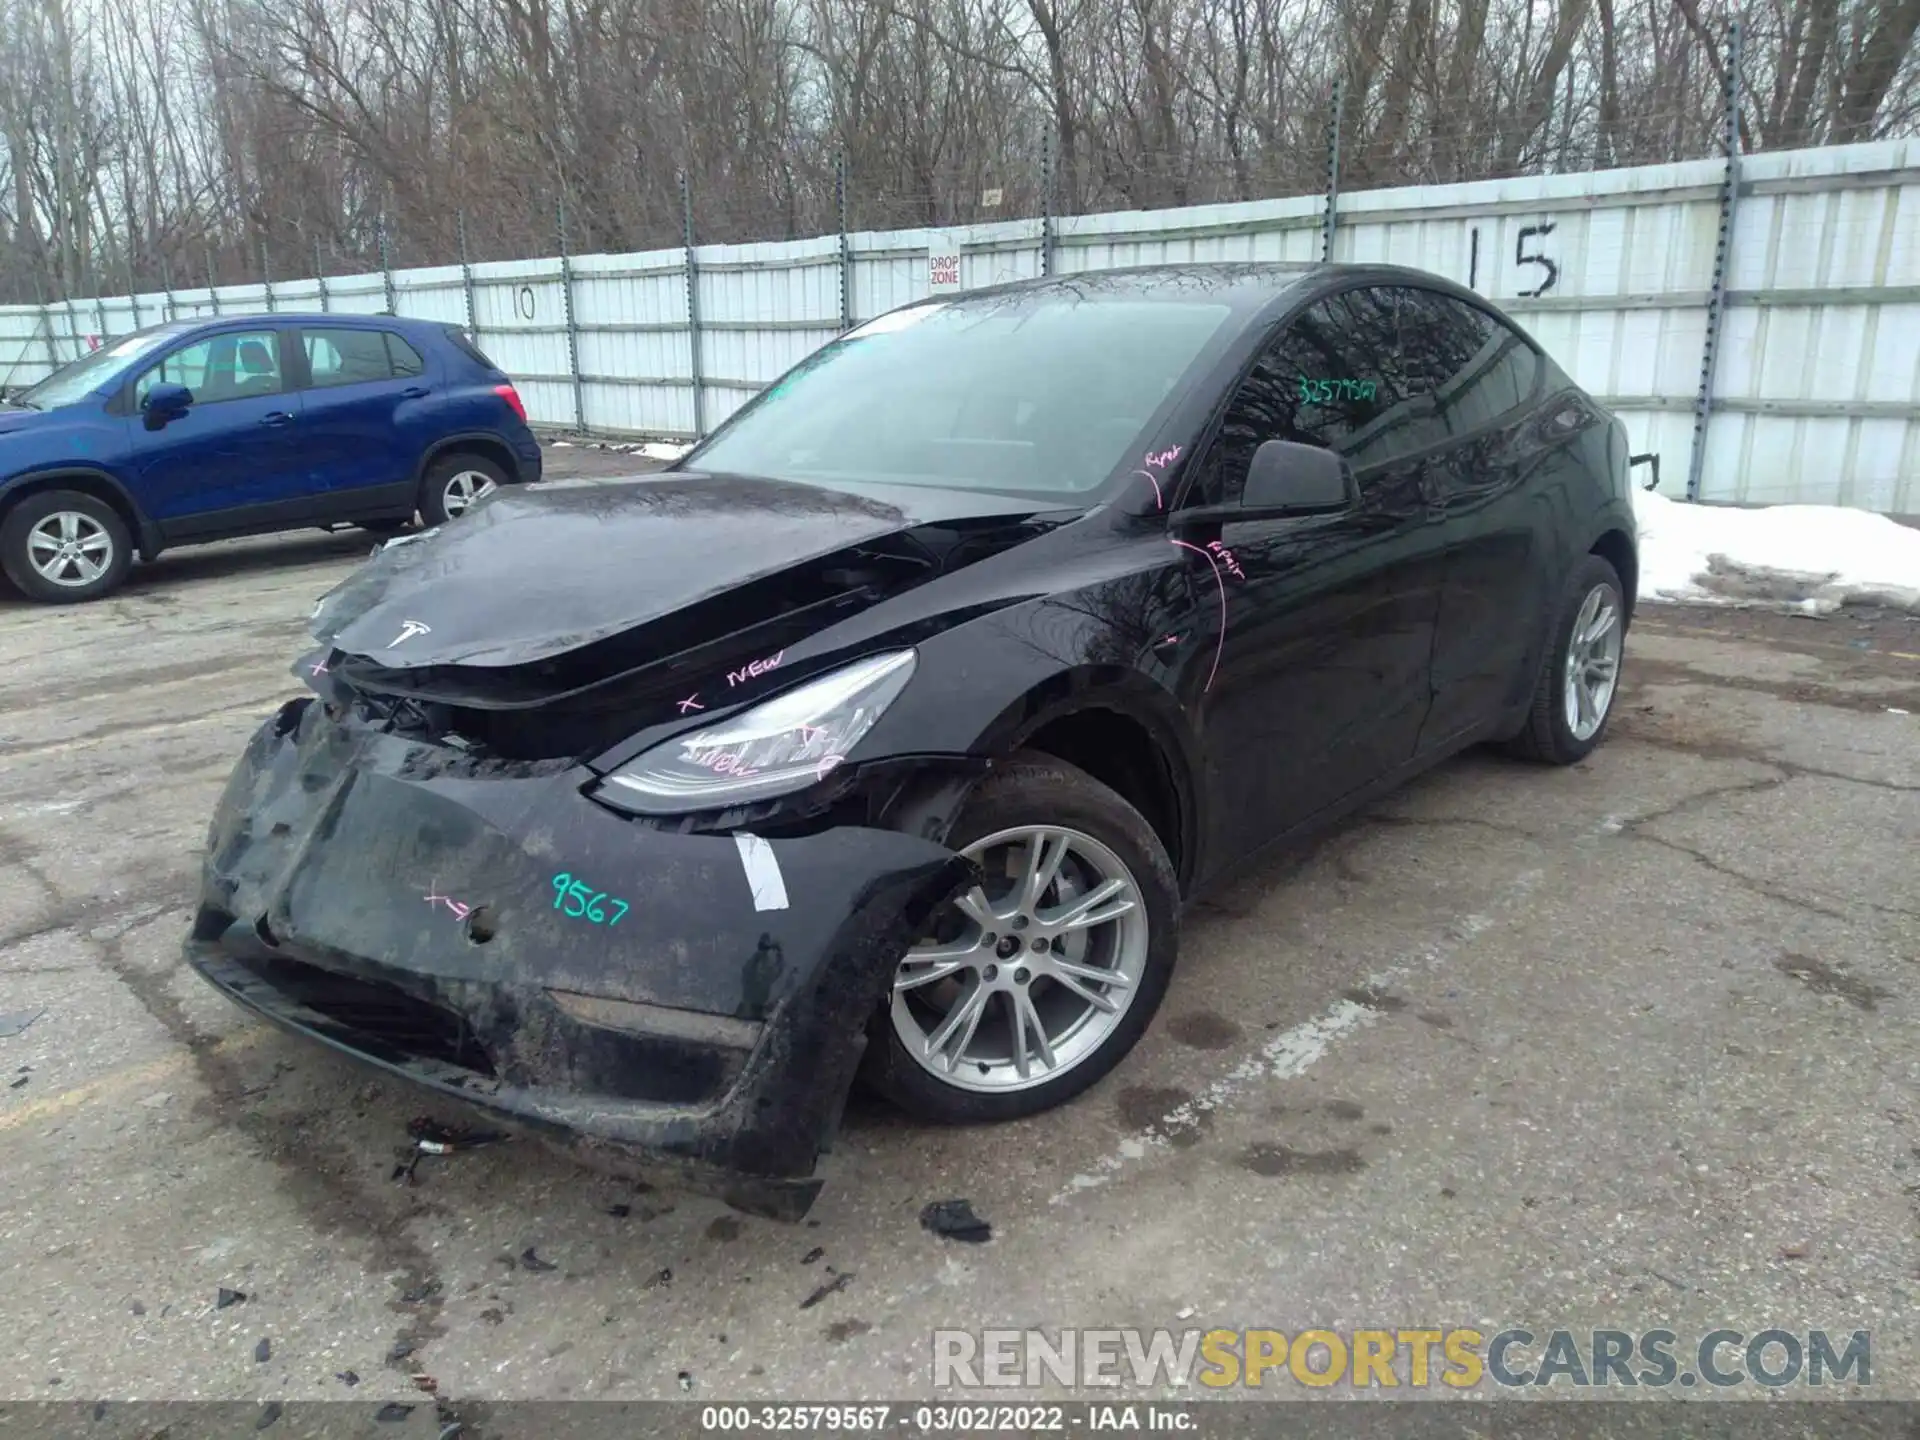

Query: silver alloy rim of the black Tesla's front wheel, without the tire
[893,826,1148,1094]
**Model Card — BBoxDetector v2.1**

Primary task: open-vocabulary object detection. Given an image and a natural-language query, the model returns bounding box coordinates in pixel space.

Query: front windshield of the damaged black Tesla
[687,290,1229,495]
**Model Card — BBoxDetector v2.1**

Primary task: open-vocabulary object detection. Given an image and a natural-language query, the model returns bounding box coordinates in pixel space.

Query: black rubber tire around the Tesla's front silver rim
[860,753,1179,1125]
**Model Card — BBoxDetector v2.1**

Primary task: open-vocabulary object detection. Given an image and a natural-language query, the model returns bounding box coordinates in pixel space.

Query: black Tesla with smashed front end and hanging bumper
[186,265,1636,1217]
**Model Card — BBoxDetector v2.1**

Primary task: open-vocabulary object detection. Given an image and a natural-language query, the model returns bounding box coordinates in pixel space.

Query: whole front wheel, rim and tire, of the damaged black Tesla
[866,755,1179,1123]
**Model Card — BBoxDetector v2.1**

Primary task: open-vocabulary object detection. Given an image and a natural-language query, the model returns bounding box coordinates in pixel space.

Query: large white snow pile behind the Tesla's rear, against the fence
[1634,490,1920,614]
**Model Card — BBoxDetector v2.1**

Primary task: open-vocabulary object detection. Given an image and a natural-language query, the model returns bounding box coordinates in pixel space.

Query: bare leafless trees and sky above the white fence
[0,0,1920,298]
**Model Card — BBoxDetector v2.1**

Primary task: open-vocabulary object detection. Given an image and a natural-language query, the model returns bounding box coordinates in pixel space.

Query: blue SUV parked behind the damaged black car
[0,313,540,603]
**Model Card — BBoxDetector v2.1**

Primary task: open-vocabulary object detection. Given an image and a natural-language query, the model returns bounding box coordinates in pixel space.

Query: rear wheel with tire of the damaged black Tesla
[1507,555,1626,764]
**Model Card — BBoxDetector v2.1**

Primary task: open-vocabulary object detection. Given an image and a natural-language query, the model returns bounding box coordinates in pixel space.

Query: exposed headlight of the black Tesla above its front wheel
[595,651,914,814]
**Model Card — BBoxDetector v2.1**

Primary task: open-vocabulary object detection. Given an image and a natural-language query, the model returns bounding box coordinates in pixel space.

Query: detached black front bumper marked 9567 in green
[184,699,972,1219]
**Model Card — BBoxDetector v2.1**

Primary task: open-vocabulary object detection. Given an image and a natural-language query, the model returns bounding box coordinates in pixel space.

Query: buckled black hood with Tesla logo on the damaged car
[311,472,1075,670]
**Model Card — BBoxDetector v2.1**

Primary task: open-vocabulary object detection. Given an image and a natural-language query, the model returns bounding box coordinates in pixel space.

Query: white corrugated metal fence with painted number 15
[0,140,1920,515]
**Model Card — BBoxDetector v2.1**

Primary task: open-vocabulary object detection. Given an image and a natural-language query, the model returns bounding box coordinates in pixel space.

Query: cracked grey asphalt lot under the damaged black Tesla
[0,468,1920,1404]
